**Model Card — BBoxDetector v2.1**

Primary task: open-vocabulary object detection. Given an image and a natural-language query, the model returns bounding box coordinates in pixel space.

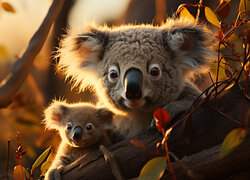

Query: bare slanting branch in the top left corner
[0,0,64,108]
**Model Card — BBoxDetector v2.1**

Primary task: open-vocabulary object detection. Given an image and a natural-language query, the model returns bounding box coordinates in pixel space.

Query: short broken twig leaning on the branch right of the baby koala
[100,145,125,180]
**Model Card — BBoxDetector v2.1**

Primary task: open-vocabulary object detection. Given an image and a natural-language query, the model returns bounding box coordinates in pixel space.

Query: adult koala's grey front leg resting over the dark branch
[150,84,201,132]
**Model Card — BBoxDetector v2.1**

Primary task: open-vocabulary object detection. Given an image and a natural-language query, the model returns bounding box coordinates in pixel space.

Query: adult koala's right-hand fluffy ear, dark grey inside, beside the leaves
[163,19,215,72]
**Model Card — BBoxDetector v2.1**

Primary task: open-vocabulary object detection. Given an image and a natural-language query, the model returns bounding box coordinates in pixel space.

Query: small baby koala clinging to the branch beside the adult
[44,101,113,180]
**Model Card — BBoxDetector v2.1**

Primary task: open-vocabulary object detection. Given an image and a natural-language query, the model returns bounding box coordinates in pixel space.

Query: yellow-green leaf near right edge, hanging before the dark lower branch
[220,128,247,158]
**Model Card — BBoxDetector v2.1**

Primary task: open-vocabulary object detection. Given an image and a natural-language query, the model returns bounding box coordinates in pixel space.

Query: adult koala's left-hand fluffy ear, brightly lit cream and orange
[57,28,108,89]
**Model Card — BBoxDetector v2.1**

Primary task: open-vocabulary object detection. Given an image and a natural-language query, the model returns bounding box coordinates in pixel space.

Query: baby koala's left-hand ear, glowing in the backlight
[44,101,68,129]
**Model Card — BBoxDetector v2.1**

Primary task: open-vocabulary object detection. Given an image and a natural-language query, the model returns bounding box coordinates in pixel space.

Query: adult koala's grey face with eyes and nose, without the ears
[97,28,183,111]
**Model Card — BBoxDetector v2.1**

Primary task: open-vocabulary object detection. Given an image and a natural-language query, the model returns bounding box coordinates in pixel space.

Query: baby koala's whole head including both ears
[45,102,112,147]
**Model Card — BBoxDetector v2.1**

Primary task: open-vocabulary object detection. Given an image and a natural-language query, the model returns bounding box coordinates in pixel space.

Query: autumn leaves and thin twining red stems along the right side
[133,0,250,179]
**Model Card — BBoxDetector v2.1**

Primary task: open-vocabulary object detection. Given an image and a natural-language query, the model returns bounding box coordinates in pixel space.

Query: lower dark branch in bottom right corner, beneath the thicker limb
[164,132,250,179]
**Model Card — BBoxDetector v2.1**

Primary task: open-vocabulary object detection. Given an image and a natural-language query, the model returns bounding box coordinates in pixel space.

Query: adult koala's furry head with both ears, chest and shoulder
[58,18,214,138]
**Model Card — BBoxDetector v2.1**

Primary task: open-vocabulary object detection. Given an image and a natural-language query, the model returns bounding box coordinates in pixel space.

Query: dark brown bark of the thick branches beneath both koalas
[62,81,250,179]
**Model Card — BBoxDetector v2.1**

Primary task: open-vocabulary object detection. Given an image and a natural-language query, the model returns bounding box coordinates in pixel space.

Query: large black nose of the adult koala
[124,68,143,99]
